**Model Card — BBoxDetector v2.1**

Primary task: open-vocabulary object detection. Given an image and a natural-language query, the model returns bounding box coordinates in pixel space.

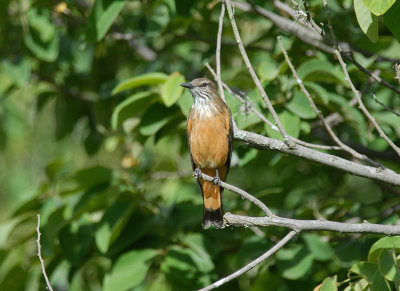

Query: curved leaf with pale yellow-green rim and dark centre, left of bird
[111,91,155,131]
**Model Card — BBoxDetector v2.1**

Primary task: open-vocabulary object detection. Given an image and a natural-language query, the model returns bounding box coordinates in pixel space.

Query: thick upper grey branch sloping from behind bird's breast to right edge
[235,129,400,186]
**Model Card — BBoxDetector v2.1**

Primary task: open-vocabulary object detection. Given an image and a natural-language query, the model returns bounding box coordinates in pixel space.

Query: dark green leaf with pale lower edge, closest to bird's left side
[139,103,176,136]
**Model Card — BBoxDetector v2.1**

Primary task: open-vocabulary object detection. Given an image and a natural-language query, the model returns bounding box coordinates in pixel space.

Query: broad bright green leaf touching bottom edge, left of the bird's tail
[104,249,157,291]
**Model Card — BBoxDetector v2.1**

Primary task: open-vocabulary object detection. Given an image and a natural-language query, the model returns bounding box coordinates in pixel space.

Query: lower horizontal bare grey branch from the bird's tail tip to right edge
[224,212,400,235]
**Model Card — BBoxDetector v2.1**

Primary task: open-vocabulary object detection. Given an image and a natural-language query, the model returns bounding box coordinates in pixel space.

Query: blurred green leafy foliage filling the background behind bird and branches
[0,0,400,291]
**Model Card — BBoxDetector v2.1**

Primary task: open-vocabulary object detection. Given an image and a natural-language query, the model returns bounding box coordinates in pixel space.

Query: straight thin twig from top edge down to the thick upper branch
[226,0,295,147]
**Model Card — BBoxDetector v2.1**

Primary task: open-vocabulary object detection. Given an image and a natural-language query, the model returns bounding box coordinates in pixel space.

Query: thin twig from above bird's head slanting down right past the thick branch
[206,63,341,150]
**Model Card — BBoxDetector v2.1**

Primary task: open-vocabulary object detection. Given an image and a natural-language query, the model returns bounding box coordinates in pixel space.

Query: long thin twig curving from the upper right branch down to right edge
[335,50,400,156]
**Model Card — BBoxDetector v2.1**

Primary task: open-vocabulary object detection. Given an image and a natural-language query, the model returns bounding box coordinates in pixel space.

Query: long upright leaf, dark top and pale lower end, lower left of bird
[95,201,136,253]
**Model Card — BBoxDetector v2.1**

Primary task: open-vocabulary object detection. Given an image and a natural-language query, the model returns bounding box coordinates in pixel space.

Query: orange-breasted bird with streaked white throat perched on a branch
[181,78,233,229]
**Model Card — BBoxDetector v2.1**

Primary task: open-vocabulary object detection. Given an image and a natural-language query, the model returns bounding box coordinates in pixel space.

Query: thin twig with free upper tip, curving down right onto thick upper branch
[277,36,384,168]
